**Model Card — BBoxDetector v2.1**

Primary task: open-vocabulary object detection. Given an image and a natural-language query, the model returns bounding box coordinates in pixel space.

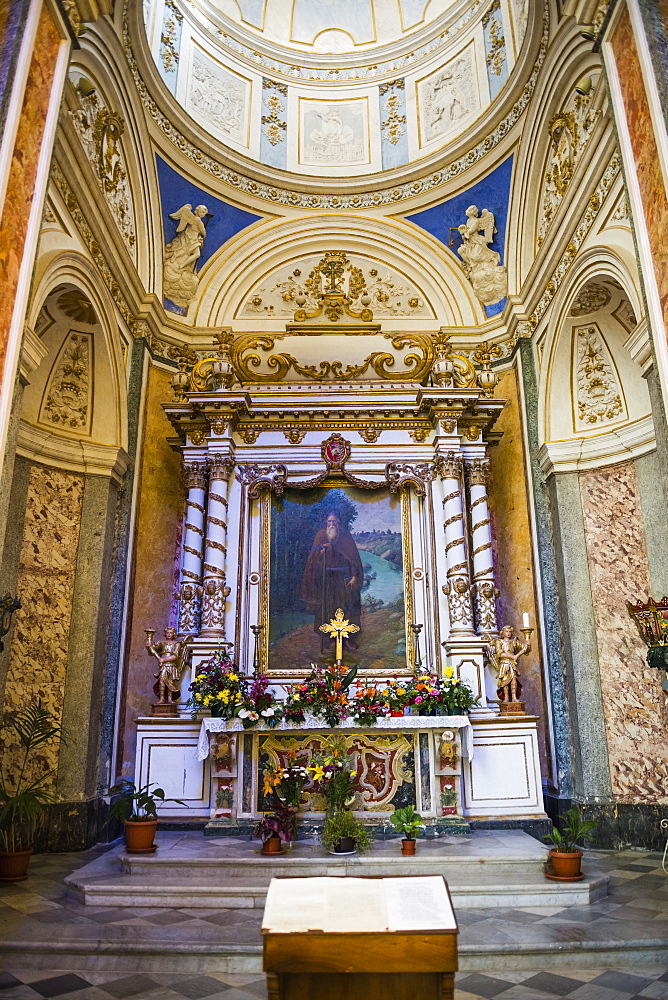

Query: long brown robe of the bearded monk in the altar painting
[299,528,364,638]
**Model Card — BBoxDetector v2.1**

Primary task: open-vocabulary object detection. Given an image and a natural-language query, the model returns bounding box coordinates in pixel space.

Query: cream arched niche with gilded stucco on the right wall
[539,265,654,471]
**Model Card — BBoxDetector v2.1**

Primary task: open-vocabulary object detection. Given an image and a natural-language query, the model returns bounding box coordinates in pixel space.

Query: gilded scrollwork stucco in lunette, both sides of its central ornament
[237,254,433,319]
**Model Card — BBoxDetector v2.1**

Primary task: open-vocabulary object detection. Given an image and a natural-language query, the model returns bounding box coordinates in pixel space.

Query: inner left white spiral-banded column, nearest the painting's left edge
[200,452,234,638]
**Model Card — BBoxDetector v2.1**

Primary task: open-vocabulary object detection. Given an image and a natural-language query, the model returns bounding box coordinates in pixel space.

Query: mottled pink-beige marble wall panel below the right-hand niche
[580,462,668,803]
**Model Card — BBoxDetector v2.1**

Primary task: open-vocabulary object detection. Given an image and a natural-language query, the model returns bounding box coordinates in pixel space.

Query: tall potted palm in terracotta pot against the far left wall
[0,702,64,881]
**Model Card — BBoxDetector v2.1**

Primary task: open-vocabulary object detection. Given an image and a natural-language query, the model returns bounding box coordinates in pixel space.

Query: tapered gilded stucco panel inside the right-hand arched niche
[573,323,626,430]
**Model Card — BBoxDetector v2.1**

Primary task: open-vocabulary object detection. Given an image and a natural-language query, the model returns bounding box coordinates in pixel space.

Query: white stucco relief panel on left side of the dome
[186,46,251,146]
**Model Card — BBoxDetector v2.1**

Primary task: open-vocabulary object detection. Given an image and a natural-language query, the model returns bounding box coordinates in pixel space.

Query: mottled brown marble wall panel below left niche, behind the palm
[4,464,84,788]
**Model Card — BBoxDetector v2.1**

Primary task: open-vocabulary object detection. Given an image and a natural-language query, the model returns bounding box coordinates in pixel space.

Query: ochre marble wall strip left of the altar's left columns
[118,367,184,775]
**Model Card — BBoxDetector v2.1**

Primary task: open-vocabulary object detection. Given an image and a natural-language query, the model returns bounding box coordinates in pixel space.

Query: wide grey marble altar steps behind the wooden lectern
[65,830,607,910]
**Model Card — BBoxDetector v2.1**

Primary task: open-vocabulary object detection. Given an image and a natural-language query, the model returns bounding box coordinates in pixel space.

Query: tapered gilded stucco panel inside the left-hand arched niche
[39,331,93,434]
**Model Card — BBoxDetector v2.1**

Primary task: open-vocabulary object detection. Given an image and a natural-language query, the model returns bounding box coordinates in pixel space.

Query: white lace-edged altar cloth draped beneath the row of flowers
[197,715,473,760]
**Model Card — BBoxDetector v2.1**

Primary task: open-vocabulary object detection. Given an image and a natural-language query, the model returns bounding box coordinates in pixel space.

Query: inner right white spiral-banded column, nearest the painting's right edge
[438,451,474,637]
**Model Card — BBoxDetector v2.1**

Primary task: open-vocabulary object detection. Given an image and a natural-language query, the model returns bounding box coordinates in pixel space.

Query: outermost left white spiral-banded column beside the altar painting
[179,462,206,635]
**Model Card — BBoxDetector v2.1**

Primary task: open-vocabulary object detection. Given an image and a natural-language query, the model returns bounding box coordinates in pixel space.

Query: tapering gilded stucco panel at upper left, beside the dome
[70,86,137,259]
